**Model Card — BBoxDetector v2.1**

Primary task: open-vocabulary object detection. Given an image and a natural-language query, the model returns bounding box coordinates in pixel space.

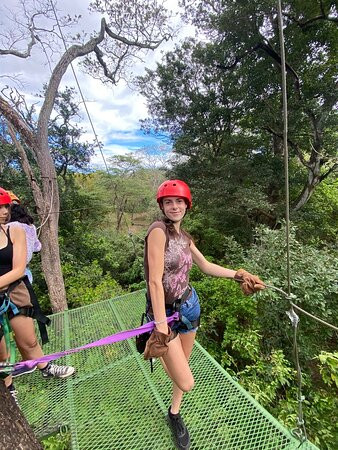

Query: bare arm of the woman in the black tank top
[0,227,27,289]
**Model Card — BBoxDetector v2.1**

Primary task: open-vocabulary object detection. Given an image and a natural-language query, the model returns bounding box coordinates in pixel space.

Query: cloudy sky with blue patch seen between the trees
[0,0,194,168]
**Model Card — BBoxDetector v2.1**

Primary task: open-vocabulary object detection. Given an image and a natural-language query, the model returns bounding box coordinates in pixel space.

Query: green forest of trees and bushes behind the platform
[0,0,338,449]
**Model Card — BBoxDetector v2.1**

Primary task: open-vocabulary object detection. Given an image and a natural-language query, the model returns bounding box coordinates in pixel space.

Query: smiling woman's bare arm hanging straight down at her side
[147,228,168,334]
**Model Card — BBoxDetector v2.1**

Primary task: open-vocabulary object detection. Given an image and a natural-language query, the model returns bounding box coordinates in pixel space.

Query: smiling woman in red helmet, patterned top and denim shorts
[144,180,264,449]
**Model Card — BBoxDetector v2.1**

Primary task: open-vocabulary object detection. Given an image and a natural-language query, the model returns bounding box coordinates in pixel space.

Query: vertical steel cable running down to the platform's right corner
[277,0,307,444]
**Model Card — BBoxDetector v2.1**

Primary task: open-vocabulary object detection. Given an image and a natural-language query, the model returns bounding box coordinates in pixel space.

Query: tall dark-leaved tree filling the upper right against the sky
[140,0,338,237]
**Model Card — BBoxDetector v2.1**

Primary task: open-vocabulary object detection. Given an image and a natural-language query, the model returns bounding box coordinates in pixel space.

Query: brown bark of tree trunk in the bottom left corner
[0,380,43,450]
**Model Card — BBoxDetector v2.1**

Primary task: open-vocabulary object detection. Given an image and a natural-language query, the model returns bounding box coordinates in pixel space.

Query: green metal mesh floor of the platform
[16,292,316,450]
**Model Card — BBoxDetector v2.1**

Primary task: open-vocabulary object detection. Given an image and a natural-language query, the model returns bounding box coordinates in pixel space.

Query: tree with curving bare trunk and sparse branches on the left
[0,0,171,311]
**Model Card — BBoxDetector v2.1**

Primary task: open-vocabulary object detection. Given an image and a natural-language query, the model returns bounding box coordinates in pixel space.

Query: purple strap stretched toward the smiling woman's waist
[13,312,179,375]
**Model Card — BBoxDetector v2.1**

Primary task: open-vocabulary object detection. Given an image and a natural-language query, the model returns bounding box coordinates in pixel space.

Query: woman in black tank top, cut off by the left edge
[0,188,75,402]
